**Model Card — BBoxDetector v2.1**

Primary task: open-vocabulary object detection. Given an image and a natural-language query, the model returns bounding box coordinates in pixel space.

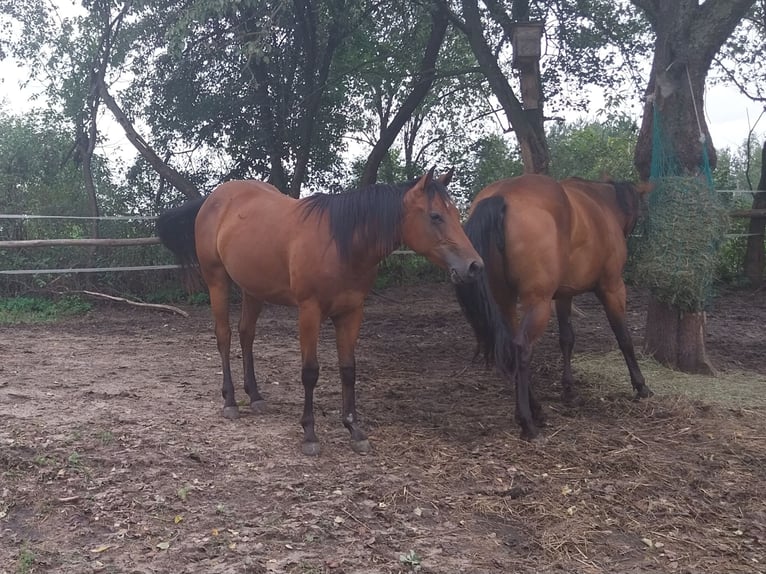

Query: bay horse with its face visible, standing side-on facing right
[157,168,483,455]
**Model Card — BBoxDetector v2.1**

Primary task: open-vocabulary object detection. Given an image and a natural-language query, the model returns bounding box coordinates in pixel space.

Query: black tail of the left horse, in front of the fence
[156,197,207,288]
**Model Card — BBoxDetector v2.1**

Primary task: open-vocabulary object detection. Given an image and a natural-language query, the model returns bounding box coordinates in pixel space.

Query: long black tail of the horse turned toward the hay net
[455,196,517,377]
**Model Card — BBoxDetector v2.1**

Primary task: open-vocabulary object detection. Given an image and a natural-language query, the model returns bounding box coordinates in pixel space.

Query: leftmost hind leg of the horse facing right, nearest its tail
[203,266,239,419]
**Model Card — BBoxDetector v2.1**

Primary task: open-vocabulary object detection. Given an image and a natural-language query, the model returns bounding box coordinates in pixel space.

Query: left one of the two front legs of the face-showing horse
[298,304,322,456]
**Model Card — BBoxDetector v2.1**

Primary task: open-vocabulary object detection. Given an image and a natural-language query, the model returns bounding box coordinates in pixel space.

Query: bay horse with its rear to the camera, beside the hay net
[455,175,652,439]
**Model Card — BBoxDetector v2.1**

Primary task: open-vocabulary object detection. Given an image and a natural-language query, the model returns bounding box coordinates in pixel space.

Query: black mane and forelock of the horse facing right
[300,178,449,262]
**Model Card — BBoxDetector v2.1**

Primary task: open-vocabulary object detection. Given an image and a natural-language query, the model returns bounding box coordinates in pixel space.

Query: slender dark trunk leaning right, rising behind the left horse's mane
[361,7,449,186]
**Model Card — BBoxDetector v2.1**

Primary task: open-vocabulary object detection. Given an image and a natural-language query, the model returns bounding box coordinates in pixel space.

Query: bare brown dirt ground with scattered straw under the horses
[0,285,766,574]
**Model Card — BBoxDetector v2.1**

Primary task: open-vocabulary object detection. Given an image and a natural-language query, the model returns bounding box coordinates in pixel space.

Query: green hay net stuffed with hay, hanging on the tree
[627,106,728,312]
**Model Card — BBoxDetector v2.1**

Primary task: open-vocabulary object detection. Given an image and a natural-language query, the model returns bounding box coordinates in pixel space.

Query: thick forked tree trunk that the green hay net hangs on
[632,0,754,372]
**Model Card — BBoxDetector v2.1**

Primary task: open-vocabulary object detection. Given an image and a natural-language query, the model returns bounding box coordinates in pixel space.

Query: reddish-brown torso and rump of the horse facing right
[196,181,375,314]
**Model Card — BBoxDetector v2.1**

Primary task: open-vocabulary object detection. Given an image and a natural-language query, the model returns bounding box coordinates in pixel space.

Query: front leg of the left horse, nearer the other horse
[332,305,370,454]
